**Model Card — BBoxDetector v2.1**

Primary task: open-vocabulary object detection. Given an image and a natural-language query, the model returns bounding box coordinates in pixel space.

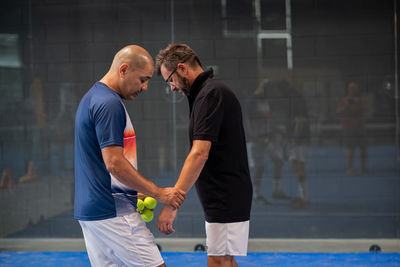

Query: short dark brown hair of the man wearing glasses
[156,44,201,74]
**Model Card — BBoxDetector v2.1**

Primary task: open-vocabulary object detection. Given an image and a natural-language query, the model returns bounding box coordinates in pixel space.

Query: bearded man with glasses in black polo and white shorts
[156,44,253,267]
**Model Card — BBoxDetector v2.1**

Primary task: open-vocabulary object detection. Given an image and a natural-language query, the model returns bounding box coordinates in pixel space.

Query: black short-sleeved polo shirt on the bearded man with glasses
[188,69,253,223]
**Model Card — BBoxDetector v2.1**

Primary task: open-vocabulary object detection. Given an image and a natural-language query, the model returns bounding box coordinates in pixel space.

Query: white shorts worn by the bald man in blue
[79,212,164,267]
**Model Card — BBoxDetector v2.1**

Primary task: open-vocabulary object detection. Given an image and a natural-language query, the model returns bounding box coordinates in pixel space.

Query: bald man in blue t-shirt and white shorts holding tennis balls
[74,45,185,266]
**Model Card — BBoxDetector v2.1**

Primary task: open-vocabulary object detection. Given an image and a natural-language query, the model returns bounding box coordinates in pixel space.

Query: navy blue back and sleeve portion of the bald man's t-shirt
[74,83,125,220]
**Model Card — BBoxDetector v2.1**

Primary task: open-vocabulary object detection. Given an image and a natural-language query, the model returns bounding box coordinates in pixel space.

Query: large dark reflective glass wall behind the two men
[0,0,400,238]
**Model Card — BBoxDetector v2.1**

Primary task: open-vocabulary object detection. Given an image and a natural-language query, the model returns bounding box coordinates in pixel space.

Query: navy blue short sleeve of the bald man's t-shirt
[92,98,126,148]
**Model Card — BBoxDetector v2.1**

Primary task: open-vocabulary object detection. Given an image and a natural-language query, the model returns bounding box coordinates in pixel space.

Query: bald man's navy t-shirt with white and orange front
[74,82,137,221]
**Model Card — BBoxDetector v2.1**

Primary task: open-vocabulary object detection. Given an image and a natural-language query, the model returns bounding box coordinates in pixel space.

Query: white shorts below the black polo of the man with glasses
[206,221,249,256]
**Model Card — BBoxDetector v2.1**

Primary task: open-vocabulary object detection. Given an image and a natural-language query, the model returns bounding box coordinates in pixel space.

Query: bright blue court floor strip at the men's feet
[0,251,400,267]
